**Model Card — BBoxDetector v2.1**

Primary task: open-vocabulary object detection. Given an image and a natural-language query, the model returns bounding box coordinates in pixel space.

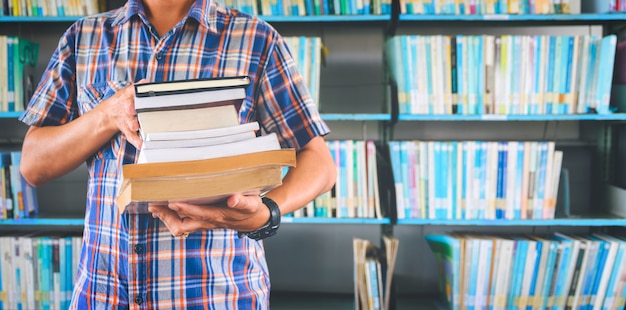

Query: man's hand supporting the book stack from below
[148,195,270,236]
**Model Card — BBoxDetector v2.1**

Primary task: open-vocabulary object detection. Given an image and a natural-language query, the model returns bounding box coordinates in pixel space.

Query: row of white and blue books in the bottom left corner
[0,236,82,310]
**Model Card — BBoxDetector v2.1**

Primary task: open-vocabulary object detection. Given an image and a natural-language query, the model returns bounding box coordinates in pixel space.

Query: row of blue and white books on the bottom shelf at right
[425,233,626,309]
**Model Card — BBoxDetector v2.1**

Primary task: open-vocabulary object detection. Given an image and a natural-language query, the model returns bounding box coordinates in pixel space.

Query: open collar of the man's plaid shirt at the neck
[113,0,221,32]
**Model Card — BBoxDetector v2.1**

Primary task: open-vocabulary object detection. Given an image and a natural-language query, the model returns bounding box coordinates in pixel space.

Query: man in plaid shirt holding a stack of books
[21,0,335,309]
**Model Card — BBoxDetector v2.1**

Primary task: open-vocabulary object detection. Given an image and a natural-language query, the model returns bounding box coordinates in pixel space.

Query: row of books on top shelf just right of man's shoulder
[224,0,391,16]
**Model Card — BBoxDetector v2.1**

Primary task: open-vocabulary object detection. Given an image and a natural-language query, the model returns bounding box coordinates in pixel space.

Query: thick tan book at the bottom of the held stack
[116,149,296,213]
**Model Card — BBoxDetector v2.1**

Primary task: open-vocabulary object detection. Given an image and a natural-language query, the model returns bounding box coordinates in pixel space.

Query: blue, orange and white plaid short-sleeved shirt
[20,0,329,309]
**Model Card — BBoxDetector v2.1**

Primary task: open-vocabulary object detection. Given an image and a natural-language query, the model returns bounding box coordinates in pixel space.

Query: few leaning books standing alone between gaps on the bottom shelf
[352,235,399,310]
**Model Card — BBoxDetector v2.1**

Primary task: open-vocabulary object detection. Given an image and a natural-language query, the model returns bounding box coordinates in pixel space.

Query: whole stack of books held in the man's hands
[116,77,295,213]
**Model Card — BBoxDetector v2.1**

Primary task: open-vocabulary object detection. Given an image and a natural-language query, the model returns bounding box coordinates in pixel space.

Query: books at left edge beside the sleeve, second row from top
[0,35,39,112]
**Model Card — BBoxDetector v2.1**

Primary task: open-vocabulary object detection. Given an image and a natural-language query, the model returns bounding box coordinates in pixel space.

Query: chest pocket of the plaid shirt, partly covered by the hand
[76,81,134,160]
